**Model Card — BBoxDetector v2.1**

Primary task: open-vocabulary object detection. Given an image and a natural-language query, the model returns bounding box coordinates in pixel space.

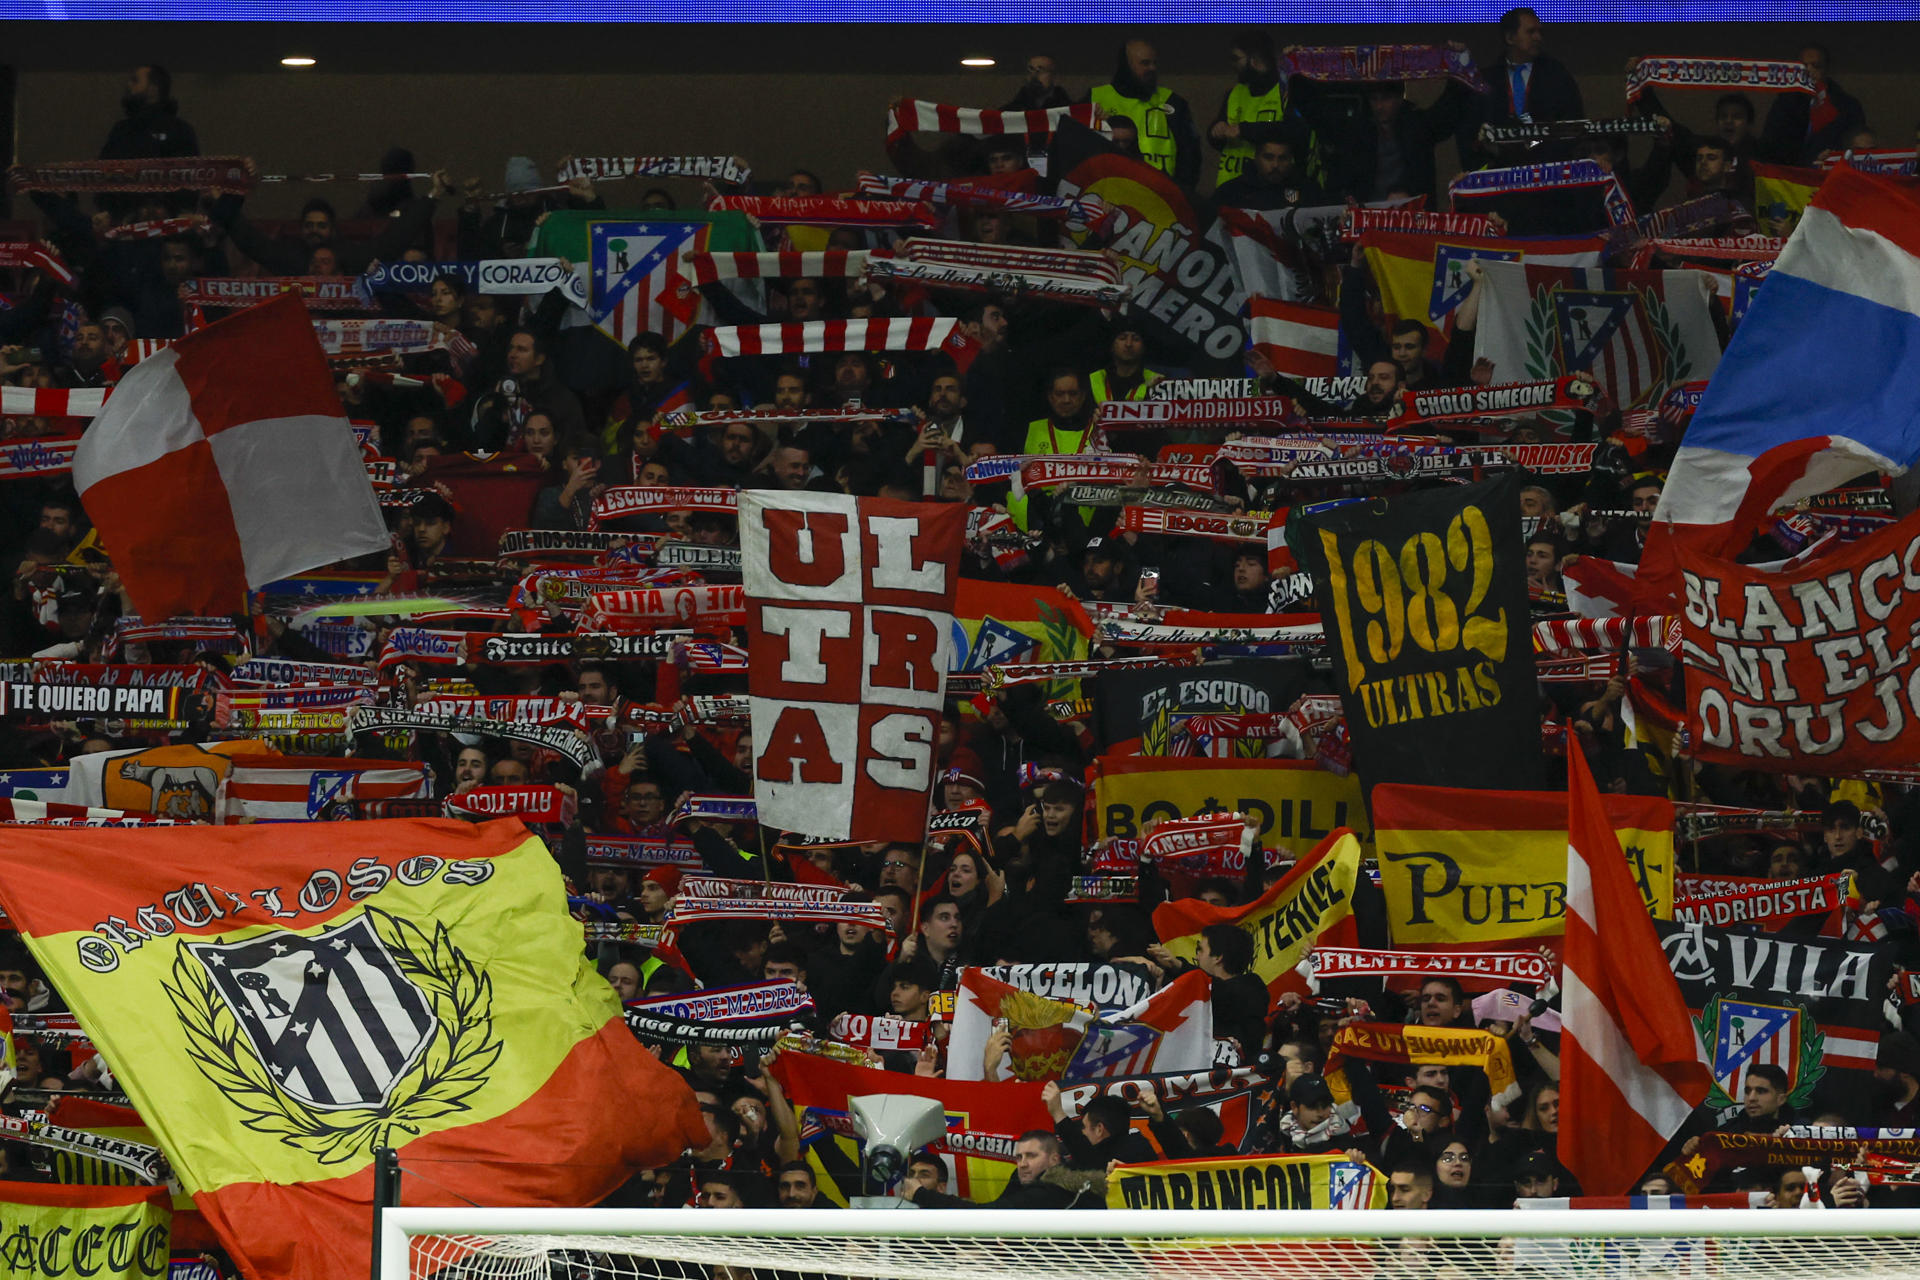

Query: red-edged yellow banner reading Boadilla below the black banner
[1092,756,1373,858]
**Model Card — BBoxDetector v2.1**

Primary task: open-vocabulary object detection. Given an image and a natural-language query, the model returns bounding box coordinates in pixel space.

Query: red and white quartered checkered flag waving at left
[73,294,388,618]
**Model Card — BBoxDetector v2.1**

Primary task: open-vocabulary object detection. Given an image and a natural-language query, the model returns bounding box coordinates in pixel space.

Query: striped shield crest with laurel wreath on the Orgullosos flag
[165,908,501,1165]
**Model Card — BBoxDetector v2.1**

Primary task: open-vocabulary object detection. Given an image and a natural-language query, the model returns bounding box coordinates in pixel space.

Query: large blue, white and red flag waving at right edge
[1638,167,1920,608]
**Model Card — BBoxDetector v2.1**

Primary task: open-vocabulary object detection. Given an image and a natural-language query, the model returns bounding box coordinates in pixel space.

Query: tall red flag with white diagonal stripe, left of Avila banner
[1559,750,1713,1196]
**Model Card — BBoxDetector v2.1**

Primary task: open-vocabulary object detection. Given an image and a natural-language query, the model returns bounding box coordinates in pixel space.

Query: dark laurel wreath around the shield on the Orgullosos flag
[161,908,501,1165]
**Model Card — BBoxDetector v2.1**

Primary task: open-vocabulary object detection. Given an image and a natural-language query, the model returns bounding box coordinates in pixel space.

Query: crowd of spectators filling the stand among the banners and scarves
[0,10,1920,1235]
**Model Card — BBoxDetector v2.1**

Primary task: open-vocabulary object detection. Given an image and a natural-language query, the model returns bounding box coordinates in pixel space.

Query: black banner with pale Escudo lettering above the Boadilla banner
[1094,658,1308,756]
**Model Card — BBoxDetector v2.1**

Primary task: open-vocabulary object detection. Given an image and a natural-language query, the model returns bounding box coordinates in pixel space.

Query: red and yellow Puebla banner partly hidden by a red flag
[1373,785,1674,946]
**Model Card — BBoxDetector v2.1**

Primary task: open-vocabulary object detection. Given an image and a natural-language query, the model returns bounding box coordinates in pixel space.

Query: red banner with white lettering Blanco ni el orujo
[1680,516,1920,773]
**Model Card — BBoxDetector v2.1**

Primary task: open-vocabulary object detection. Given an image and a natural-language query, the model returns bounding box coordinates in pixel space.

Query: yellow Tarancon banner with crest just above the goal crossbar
[1106,1155,1386,1209]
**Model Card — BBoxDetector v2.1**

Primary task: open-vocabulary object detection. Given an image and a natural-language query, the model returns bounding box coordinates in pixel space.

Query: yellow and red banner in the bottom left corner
[0,1182,173,1280]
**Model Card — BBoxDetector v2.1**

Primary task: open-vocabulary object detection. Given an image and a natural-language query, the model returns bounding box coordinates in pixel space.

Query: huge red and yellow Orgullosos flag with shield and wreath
[0,821,705,1280]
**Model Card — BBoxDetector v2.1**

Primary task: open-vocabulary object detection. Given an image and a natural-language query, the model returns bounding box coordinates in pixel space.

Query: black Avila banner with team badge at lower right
[1655,921,1895,1107]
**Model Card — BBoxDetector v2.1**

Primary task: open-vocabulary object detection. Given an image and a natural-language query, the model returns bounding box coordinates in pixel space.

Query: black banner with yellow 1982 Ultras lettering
[1286,476,1540,787]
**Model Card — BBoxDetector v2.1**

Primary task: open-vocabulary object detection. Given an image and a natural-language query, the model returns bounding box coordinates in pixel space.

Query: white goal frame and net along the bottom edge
[374,1209,1920,1280]
